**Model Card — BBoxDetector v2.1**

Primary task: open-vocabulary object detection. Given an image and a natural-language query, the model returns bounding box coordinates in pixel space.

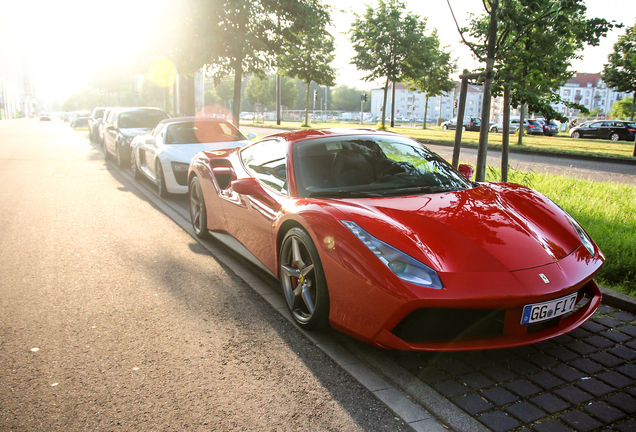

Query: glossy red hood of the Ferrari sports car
[335,184,581,272]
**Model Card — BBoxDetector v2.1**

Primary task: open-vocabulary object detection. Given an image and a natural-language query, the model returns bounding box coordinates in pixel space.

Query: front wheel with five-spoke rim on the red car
[279,228,329,330]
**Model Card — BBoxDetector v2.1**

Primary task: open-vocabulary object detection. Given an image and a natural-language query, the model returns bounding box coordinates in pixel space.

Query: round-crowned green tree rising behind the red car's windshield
[349,0,428,128]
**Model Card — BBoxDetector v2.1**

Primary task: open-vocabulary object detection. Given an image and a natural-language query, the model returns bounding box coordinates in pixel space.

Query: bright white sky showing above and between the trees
[0,0,636,102]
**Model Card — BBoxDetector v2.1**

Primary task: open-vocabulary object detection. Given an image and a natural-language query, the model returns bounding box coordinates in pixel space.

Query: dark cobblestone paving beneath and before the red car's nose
[390,304,636,432]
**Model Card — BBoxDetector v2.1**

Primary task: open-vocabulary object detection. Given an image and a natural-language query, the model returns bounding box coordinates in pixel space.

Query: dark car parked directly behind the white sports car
[104,107,170,168]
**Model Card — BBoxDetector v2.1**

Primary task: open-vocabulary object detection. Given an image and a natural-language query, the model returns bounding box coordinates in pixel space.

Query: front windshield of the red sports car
[293,136,472,198]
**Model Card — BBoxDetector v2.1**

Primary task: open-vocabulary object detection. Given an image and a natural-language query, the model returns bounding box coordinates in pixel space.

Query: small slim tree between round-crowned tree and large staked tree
[406,30,457,129]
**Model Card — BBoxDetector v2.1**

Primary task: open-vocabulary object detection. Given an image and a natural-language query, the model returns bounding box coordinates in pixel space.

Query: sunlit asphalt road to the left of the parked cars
[0,120,409,431]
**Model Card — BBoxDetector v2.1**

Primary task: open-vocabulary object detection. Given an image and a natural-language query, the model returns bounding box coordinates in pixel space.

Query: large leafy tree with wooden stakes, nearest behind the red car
[458,0,613,181]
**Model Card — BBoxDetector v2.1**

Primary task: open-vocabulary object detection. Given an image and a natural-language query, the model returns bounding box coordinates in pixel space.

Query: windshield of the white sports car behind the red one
[166,120,247,144]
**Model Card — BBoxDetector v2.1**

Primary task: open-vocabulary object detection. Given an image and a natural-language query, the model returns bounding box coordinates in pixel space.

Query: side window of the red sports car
[241,140,287,195]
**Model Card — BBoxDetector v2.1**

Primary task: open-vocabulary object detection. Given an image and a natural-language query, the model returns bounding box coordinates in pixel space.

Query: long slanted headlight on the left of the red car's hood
[340,221,444,289]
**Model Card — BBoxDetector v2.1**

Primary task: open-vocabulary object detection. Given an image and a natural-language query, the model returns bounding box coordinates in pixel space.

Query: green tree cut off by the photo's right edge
[602,25,636,123]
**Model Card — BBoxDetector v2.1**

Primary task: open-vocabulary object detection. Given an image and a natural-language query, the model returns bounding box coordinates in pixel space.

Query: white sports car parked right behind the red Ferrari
[130,117,255,197]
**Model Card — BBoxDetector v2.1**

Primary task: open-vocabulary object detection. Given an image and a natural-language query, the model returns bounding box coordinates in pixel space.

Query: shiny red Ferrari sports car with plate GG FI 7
[188,129,605,351]
